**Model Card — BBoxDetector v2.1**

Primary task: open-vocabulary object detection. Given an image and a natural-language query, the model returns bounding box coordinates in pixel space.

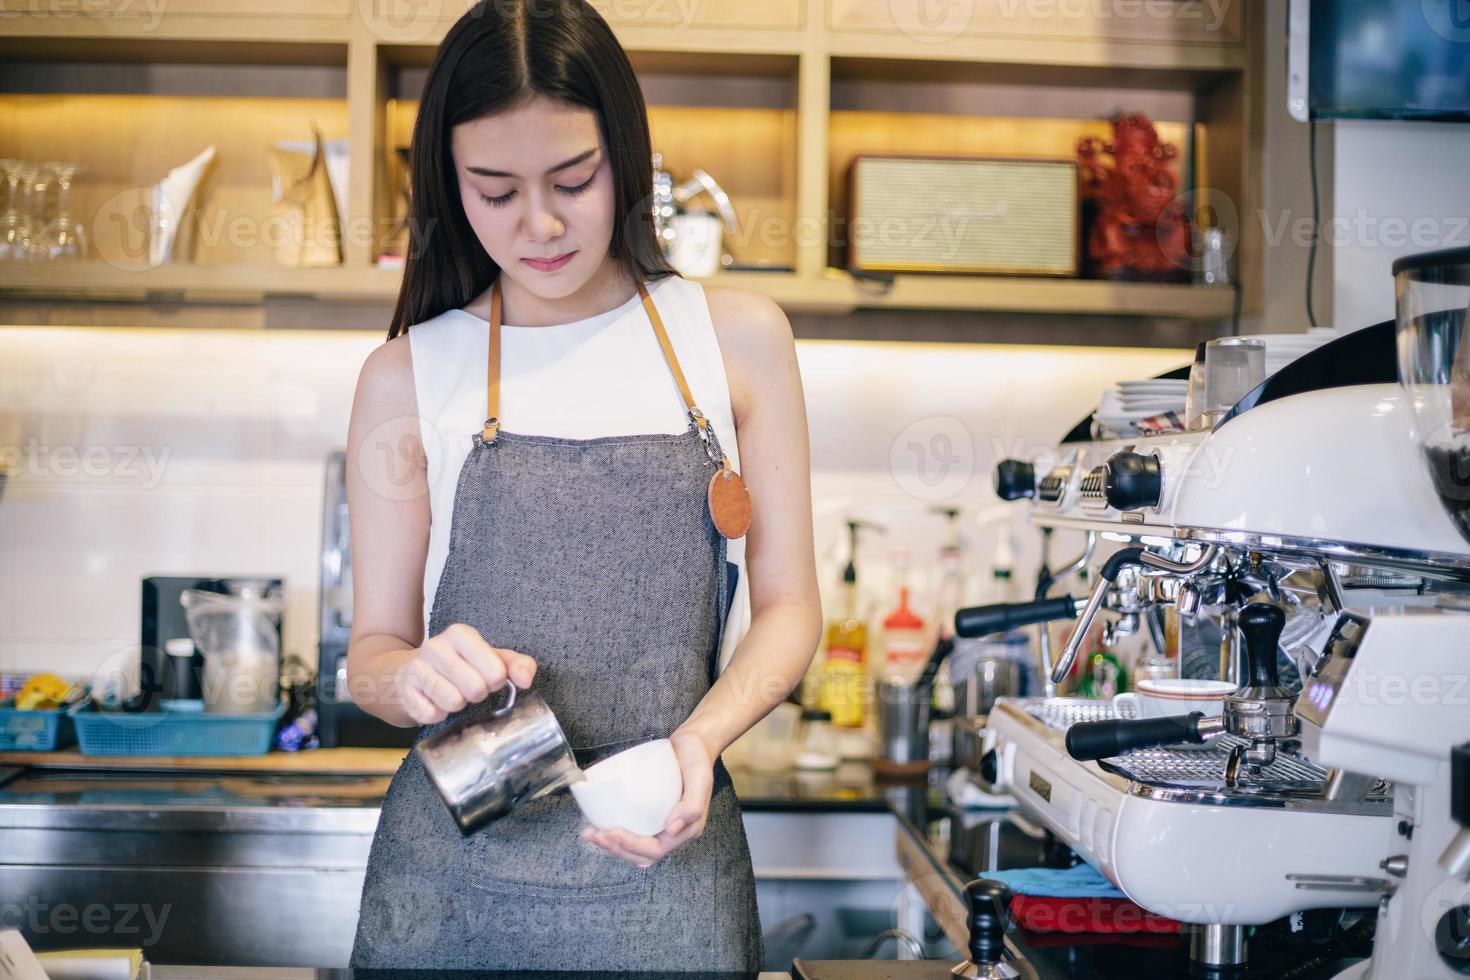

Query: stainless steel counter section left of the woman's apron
[0,770,388,967]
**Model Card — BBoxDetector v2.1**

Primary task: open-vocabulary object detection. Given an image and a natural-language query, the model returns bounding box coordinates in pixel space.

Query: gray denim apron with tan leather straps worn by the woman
[351,281,761,974]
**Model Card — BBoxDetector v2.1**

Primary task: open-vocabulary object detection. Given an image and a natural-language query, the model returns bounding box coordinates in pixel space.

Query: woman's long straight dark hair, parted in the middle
[388,0,678,339]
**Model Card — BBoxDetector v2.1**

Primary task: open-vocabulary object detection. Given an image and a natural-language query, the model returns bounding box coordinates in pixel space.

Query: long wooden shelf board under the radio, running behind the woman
[0,262,1235,320]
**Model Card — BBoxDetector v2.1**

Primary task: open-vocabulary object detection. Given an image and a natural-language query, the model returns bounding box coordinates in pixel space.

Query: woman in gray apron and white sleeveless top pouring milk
[347,0,820,971]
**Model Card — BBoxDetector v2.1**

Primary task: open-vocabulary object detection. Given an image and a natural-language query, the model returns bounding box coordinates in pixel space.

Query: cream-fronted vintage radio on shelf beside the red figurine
[847,154,1079,276]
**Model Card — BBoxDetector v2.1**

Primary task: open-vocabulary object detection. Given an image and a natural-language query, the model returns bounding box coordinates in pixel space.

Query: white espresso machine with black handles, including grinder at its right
[957,250,1470,980]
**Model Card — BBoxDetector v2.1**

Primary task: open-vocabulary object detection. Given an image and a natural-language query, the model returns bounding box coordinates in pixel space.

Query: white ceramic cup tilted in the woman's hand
[570,739,684,837]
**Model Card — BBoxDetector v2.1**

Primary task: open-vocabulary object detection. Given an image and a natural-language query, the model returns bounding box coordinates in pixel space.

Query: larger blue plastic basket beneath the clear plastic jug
[72,701,285,755]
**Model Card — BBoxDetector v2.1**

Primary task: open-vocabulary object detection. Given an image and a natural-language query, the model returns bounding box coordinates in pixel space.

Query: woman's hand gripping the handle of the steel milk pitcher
[398,623,537,724]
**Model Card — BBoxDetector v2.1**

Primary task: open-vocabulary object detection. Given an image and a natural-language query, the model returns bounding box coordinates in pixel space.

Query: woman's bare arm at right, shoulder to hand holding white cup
[584,287,822,867]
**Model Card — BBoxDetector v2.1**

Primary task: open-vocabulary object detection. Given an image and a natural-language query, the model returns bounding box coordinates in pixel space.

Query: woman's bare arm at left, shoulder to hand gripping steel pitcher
[347,335,535,727]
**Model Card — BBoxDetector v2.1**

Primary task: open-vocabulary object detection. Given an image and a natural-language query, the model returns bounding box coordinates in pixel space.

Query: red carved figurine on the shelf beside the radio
[1078,113,1189,281]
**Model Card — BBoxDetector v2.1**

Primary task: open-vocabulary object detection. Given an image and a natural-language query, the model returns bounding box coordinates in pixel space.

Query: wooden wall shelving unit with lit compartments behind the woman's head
[0,0,1264,333]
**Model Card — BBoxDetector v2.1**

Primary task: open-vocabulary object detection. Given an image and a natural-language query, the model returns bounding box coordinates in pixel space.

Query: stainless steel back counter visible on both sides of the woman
[0,760,903,968]
